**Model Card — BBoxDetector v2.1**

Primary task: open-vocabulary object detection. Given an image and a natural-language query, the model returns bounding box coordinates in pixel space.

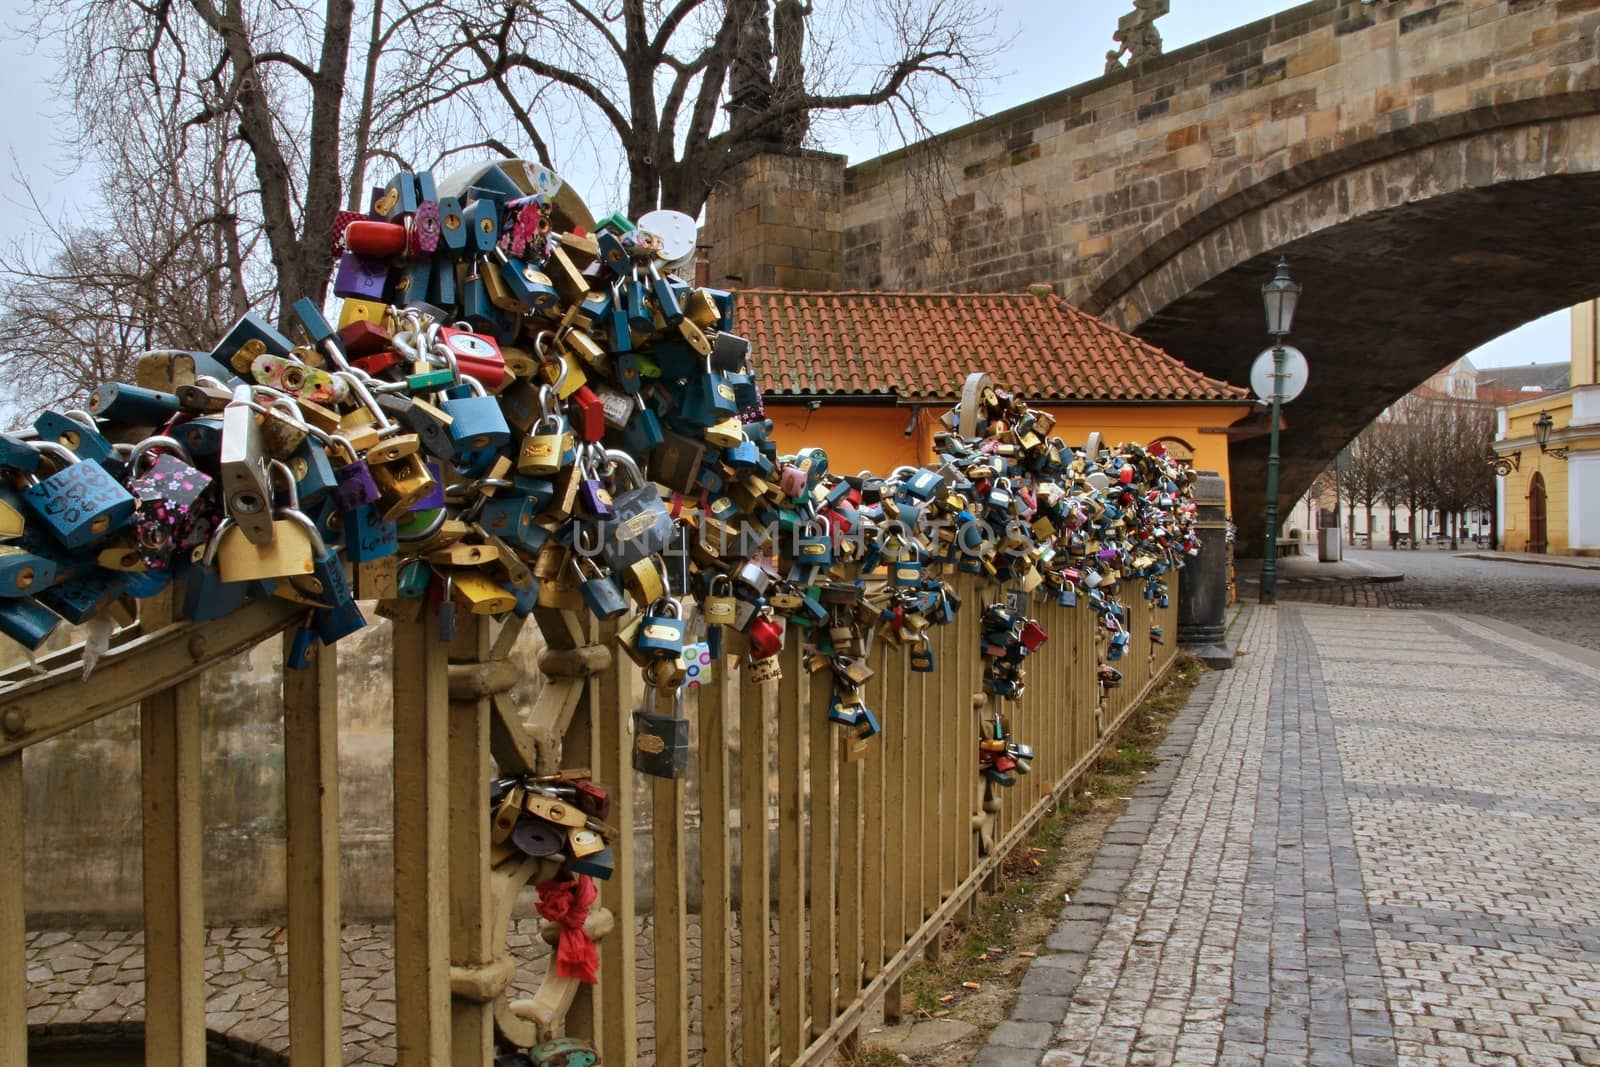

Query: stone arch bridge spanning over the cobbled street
[723,0,1600,542]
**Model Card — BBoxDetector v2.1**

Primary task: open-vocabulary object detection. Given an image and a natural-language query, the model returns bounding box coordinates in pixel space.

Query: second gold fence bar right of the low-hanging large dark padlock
[739,661,778,1064]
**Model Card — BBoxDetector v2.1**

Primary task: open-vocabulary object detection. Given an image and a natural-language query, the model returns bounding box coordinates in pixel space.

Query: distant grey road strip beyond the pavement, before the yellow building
[1324,547,1600,651]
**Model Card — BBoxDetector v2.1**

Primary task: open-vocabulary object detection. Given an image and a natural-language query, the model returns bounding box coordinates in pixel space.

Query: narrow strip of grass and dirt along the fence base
[876,654,1205,1036]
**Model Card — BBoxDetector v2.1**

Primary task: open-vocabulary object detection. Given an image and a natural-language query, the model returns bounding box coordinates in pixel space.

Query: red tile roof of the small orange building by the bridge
[734,290,1250,403]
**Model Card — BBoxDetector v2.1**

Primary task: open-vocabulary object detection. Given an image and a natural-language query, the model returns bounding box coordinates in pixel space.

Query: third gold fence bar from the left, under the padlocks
[283,633,344,1067]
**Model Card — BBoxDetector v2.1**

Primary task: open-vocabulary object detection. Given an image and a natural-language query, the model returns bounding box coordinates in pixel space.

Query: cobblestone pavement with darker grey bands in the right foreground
[974,604,1600,1067]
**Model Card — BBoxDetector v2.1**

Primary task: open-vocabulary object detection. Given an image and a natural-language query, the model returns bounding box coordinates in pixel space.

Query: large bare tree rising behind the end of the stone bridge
[390,0,994,214]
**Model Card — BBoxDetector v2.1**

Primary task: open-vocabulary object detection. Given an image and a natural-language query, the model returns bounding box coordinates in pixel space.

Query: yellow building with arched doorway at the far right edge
[1494,301,1600,555]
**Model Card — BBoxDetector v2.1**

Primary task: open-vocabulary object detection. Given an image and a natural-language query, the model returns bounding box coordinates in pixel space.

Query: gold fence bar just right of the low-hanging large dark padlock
[699,652,734,1064]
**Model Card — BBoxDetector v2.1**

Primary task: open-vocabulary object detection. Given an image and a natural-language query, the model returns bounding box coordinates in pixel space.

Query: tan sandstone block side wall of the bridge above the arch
[832,0,1600,328]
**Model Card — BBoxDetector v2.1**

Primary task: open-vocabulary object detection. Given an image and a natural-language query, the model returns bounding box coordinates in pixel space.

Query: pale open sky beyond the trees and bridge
[0,0,1568,368]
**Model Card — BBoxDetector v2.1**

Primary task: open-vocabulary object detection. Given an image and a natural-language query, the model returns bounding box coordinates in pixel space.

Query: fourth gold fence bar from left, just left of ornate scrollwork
[394,613,454,1067]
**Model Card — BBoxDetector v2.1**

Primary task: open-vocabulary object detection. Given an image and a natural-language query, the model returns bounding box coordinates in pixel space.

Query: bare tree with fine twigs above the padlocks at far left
[0,81,272,416]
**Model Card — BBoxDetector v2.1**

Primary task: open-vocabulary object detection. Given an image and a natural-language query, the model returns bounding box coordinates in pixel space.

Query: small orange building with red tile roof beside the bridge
[734,286,1253,508]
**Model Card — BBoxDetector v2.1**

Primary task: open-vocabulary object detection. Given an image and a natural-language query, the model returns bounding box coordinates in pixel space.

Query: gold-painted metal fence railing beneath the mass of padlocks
[0,574,1178,1067]
